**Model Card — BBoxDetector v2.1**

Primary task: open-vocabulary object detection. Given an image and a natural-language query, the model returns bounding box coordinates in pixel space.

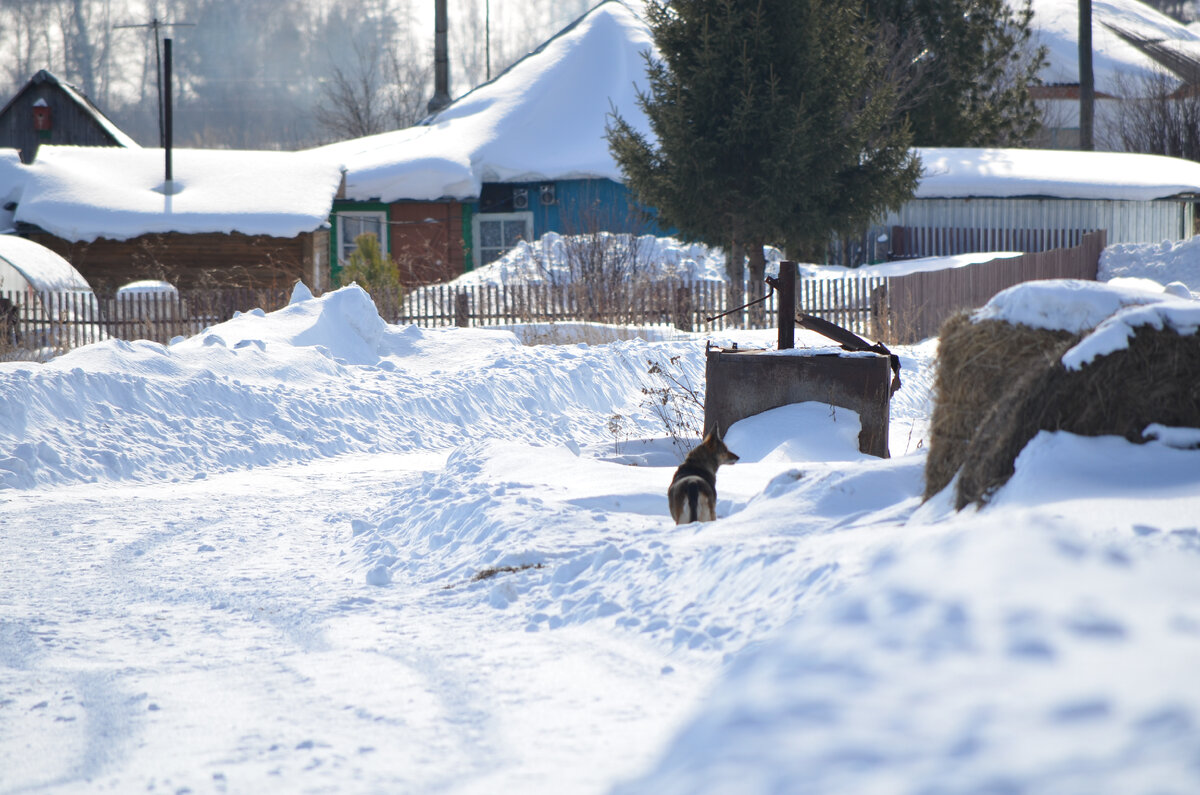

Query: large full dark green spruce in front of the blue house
[607,0,919,312]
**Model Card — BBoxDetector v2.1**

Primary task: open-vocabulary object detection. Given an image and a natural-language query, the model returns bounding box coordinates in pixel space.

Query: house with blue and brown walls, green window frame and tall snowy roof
[314,0,655,283]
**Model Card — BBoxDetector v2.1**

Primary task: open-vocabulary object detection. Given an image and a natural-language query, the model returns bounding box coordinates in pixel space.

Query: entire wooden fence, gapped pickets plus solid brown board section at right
[0,232,1106,358]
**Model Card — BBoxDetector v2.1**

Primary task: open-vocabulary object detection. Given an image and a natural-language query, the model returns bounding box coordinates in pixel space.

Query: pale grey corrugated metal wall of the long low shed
[871,198,1195,253]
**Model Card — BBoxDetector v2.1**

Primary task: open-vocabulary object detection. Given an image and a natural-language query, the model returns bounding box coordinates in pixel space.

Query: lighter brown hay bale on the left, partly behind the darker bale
[925,312,1079,500]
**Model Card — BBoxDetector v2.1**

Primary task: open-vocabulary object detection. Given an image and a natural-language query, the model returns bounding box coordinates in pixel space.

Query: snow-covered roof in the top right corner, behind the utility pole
[1032,0,1200,96]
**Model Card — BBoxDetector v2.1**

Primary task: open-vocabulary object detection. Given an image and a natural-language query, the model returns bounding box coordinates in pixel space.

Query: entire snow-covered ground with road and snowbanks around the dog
[0,253,1200,794]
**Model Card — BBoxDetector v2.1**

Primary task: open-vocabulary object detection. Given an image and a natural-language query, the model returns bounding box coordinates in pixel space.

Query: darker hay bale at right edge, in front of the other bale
[955,325,1200,510]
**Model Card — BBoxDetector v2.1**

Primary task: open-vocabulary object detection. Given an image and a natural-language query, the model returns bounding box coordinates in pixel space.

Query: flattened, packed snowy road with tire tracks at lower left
[0,455,715,793]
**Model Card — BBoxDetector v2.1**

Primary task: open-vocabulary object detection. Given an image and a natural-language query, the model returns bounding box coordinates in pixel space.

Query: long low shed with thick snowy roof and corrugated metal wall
[868,148,1200,258]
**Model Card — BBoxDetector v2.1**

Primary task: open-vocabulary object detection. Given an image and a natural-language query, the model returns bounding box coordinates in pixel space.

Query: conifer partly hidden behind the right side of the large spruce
[863,0,1045,147]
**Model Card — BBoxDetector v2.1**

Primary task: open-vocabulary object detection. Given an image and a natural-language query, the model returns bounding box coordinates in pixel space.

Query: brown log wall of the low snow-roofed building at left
[28,233,329,295]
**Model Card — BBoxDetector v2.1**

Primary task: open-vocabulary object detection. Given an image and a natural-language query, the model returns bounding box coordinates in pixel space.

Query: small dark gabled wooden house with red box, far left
[0,70,138,163]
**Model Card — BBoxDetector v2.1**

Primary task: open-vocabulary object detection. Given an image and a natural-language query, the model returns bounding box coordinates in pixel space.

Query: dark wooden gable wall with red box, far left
[0,82,127,163]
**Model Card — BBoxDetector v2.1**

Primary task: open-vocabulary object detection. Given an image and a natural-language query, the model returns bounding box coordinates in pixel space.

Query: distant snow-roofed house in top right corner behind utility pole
[1031,0,1200,149]
